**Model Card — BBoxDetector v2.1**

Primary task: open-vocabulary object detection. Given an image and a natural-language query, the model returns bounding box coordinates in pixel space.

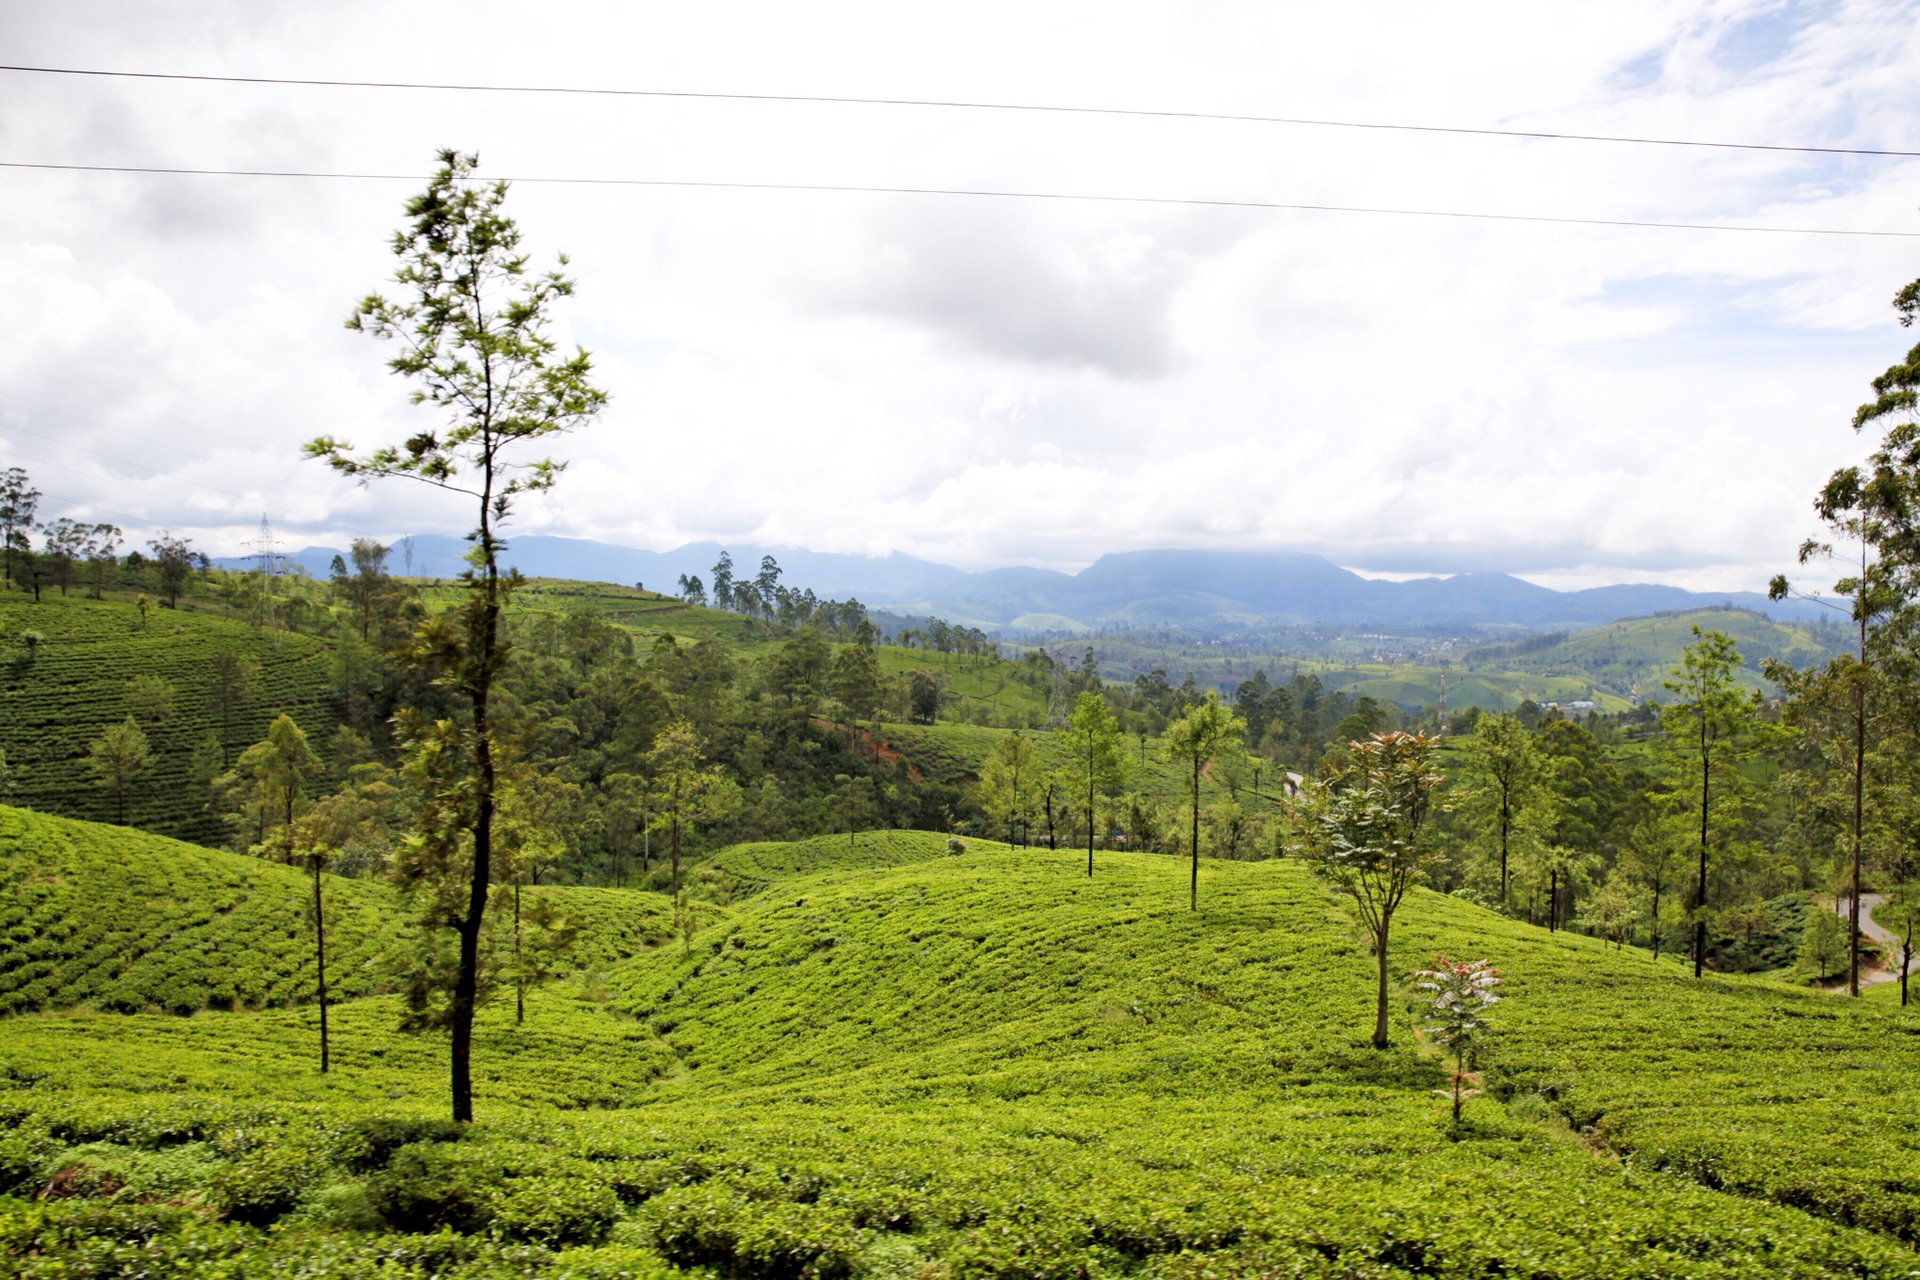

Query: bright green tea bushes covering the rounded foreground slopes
[0,816,1920,1280]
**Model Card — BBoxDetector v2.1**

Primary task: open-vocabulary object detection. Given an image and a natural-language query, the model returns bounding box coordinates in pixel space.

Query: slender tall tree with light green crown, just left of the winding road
[1661,624,1759,977]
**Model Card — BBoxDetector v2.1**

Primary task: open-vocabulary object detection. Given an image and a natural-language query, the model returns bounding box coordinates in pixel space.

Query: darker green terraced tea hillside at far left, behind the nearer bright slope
[0,593,338,842]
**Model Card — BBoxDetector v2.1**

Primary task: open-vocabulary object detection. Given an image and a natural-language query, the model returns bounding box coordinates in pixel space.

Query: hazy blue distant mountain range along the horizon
[227,533,1820,635]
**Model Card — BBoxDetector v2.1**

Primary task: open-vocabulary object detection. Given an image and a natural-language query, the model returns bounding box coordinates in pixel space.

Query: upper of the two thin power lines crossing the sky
[0,63,1920,159]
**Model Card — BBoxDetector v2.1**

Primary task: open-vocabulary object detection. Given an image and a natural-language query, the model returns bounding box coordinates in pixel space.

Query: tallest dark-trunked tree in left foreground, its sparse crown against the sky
[307,150,607,1123]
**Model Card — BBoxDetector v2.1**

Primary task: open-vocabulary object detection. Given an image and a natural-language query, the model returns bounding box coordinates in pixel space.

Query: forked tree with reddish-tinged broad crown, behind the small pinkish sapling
[1302,729,1446,1050]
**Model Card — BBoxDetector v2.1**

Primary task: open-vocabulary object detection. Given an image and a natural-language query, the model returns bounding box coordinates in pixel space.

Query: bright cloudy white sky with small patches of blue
[0,0,1920,591]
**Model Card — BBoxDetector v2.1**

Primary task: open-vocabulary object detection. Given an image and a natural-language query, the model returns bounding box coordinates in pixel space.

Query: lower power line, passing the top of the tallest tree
[0,159,1920,240]
